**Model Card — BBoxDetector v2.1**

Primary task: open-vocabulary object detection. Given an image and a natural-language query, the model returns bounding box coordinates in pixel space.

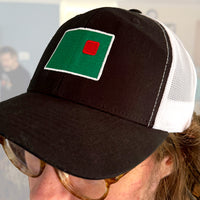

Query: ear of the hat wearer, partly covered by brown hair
[159,156,173,179]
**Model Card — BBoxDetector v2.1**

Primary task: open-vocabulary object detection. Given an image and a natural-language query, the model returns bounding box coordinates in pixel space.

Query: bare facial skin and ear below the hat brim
[29,155,173,200]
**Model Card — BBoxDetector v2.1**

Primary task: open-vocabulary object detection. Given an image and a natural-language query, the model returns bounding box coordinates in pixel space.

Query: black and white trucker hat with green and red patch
[0,8,196,179]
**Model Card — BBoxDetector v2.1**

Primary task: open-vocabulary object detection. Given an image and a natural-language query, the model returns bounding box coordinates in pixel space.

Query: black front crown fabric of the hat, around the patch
[28,8,172,126]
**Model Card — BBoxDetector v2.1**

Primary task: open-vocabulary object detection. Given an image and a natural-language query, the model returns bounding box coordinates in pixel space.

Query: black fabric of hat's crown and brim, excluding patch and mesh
[0,8,172,179]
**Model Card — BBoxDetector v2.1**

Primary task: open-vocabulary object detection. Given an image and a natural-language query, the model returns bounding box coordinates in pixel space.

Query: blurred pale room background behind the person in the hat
[0,0,200,200]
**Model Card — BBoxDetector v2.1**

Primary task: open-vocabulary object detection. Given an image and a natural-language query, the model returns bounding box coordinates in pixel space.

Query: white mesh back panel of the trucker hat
[153,22,196,132]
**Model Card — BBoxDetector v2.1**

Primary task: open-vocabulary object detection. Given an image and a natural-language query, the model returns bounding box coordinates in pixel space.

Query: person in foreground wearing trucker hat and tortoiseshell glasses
[0,8,200,200]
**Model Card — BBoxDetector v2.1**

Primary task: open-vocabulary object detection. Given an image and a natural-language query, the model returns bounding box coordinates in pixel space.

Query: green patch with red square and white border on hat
[44,28,115,80]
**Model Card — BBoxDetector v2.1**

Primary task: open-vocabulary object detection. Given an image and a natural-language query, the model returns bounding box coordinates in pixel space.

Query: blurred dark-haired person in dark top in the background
[0,46,30,101]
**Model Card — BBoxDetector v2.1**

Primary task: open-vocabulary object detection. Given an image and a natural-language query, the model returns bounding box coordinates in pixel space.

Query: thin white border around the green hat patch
[44,27,115,81]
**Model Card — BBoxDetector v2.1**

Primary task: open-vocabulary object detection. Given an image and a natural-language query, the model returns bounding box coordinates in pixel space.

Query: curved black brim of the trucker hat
[0,93,168,179]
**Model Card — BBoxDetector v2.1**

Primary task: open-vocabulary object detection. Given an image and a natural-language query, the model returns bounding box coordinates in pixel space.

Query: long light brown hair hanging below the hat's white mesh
[154,113,200,200]
